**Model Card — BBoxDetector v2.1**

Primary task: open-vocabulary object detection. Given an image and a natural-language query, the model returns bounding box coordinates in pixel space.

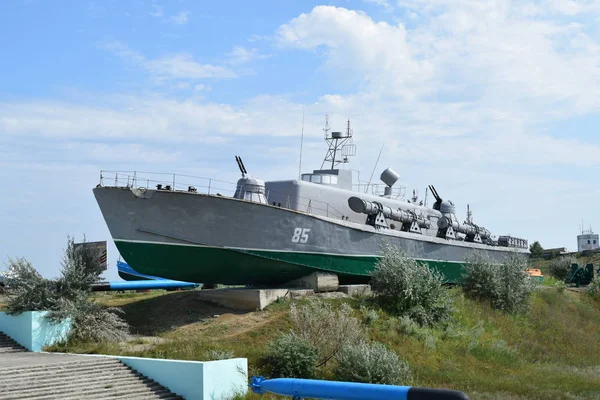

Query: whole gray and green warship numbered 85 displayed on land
[93,120,529,286]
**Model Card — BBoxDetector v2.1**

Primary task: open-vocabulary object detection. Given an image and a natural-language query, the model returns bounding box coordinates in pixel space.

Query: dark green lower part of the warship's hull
[115,240,462,285]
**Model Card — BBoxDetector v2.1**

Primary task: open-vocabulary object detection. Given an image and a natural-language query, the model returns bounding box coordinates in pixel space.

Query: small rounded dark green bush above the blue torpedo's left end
[265,334,318,379]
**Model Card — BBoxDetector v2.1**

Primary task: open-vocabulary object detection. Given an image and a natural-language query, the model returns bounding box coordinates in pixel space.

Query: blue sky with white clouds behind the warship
[0,0,600,280]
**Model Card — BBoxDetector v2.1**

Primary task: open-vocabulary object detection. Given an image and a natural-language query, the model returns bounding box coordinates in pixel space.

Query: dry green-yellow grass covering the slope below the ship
[43,288,600,399]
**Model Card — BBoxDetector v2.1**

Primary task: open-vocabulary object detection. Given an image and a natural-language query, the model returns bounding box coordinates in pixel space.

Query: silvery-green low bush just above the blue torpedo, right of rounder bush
[334,341,410,385]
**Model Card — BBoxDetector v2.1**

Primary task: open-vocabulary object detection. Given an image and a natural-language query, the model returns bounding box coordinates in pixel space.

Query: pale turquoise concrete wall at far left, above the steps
[0,311,71,352]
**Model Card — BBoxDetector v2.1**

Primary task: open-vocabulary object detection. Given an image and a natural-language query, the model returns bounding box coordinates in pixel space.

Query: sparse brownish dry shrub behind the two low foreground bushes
[290,299,364,367]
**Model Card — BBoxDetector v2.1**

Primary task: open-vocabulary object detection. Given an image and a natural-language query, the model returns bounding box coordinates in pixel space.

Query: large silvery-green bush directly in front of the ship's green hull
[371,247,452,325]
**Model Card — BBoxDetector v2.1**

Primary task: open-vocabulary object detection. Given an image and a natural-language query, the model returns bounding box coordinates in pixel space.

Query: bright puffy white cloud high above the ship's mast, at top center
[278,6,434,97]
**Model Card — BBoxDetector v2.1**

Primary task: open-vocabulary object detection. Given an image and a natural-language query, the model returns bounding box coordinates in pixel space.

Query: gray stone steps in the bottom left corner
[0,334,183,400]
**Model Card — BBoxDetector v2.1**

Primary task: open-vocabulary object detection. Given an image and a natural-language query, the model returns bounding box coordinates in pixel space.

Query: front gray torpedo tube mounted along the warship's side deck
[348,196,431,233]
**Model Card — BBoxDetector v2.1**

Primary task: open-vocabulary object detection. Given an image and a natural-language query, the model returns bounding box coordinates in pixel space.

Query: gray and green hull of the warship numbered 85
[94,187,528,285]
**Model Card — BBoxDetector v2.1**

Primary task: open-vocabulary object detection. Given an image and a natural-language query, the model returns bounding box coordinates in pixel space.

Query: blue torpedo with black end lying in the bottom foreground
[250,376,469,400]
